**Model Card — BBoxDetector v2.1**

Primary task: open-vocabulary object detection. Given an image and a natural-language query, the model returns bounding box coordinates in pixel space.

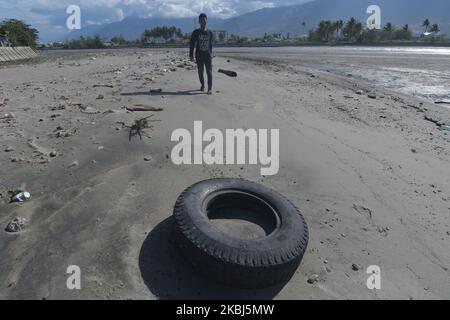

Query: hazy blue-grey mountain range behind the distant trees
[66,0,450,40]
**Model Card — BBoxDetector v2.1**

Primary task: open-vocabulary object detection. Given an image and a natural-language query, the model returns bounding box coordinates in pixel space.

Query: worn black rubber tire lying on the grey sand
[174,179,308,289]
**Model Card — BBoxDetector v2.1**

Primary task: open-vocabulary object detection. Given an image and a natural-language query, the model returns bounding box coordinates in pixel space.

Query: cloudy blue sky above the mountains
[0,0,306,41]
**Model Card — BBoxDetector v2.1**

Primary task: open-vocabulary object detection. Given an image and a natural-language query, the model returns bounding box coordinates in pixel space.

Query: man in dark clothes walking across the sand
[189,13,214,94]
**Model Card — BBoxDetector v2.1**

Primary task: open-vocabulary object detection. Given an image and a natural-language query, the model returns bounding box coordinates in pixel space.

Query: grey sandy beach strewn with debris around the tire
[0,49,450,300]
